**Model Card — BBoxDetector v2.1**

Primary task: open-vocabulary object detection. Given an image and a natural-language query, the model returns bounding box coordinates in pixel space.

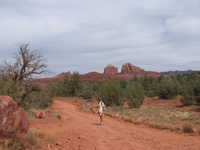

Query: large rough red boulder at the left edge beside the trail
[0,96,29,137]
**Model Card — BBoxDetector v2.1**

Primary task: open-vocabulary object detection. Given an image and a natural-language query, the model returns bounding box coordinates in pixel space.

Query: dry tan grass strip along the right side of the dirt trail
[76,98,200,134]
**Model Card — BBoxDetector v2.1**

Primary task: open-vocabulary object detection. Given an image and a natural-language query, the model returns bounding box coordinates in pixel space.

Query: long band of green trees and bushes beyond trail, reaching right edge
[57,73,200,107]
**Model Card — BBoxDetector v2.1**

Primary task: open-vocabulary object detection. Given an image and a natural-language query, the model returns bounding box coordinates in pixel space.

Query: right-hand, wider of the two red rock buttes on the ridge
[121,63,144,74]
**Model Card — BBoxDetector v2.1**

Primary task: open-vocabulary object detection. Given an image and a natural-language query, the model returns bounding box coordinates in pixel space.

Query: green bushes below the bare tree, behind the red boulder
[0,80,55,109]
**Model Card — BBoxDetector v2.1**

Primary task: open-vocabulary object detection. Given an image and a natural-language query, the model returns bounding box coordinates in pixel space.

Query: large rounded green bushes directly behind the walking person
[95,81,144,107]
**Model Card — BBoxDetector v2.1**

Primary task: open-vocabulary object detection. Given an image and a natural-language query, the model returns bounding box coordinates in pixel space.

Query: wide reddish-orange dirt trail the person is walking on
[32,99,200,150]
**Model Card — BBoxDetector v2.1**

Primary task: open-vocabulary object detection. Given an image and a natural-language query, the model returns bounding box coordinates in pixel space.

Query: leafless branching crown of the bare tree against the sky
[1,44,47,81]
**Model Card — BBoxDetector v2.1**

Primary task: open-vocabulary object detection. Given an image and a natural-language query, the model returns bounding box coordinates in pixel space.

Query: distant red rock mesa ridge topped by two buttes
[32,63,161,83]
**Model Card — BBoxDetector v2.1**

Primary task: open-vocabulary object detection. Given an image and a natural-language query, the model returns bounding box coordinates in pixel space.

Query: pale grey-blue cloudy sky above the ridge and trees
[0,0,200,74]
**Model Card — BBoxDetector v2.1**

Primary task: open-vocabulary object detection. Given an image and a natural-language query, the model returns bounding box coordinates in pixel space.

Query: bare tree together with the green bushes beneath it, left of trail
[0,44,54,109]
